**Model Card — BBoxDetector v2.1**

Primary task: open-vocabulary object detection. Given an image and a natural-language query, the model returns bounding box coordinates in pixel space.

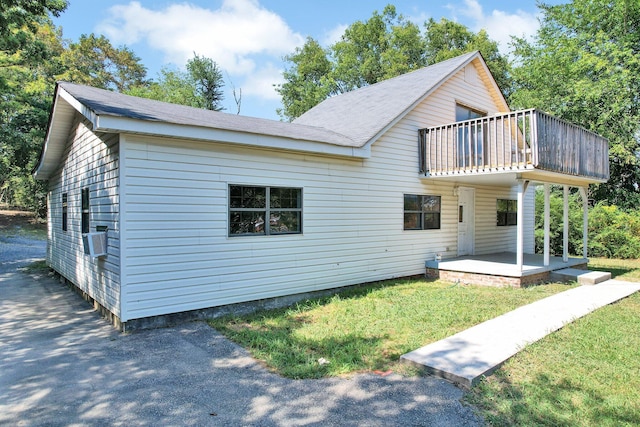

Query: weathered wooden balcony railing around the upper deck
[419,109,609,180]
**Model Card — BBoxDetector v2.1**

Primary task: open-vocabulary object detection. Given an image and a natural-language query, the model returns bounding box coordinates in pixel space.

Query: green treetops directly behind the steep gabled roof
[276,5,509,120]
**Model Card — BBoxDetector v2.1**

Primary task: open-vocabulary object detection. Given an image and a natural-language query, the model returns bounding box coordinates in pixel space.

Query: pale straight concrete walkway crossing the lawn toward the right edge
[402,280,640,388]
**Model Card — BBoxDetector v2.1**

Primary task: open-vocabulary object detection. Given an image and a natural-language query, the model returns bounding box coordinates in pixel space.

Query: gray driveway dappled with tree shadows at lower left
[0,229,482,426]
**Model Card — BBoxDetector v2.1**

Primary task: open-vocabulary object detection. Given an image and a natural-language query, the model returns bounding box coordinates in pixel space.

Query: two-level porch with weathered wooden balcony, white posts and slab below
[418,109,610,272]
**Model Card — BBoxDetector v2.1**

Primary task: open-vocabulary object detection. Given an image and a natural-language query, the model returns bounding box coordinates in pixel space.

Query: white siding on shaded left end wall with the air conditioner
[47,115,120,316]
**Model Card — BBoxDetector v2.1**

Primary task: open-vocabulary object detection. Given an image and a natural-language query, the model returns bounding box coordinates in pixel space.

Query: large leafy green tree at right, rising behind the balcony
[511,0,640,209]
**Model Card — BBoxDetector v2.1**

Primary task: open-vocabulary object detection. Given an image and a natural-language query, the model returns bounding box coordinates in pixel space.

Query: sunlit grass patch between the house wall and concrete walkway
[210,280,567,378]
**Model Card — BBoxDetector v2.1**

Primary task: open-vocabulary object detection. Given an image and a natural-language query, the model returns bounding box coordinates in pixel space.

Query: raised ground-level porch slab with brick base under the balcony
[425,252,588,287]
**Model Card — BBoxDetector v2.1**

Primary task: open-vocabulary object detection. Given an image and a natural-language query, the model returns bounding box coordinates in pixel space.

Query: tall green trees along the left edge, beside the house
[0,0,67,215]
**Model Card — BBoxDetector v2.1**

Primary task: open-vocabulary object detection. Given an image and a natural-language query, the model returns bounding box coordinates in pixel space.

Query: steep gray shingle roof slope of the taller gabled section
[293,52,479,147]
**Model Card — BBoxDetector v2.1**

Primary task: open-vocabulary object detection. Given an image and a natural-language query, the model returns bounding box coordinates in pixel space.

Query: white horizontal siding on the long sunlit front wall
[120,63,533,321]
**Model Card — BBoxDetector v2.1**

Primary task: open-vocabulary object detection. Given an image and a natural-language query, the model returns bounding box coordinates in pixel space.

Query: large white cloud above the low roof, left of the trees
[98,0,304,75]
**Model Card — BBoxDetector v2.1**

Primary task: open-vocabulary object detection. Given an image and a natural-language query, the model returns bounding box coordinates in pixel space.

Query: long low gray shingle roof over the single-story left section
[59,82,355,147]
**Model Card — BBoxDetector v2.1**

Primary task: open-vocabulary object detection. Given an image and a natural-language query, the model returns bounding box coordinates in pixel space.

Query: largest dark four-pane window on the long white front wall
[229,185,302,236]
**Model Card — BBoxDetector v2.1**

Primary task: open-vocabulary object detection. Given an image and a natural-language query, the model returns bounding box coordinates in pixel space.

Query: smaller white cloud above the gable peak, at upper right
[447,0,539,53]
